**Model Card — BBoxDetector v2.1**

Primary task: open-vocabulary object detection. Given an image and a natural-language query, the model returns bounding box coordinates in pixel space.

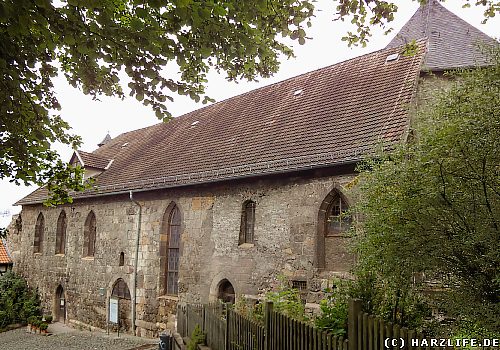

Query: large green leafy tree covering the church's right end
[355,48,500,331]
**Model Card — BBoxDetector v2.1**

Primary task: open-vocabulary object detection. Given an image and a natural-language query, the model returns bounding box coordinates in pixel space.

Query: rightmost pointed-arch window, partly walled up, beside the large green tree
[316,189,353,272]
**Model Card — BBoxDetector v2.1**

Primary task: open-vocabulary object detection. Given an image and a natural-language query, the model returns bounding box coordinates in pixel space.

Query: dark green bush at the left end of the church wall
[0,271,40,329]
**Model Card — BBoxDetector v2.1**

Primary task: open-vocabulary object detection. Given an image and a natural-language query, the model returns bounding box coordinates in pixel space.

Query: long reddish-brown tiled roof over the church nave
[17,42,425,204]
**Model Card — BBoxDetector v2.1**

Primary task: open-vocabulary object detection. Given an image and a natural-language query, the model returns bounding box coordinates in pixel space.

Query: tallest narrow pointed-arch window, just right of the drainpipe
[160,203,181,295]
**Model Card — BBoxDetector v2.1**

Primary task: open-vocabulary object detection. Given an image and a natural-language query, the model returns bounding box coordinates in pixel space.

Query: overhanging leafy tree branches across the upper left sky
[0,0,499,208]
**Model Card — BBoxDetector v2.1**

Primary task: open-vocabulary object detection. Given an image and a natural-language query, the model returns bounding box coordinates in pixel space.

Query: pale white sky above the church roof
[0,0,500,227]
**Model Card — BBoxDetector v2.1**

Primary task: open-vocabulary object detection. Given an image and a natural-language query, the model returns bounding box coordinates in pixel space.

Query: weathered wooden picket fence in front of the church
[177,300,458,350]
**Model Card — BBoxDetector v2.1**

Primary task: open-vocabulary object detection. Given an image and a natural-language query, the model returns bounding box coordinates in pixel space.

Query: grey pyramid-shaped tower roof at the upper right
[387,0,498,71]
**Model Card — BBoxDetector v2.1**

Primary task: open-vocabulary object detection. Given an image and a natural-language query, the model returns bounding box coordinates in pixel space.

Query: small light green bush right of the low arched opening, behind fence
[266,276,308,321]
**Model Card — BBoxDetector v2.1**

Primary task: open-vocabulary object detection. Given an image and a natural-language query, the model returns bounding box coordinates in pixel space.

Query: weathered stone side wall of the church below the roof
[10,167,353,337]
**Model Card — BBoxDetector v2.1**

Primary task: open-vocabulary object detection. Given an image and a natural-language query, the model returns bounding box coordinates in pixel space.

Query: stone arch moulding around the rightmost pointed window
[315,183,352,270]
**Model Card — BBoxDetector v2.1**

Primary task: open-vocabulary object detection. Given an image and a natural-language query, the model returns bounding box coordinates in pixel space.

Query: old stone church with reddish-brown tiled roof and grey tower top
[9,1,497,337]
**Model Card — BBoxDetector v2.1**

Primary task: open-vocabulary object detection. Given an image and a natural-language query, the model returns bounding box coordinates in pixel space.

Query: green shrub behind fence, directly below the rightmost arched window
[315,279,350,336]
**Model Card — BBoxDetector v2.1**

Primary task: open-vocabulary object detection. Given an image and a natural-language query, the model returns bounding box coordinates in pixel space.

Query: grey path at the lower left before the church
[0,327,158,350]
